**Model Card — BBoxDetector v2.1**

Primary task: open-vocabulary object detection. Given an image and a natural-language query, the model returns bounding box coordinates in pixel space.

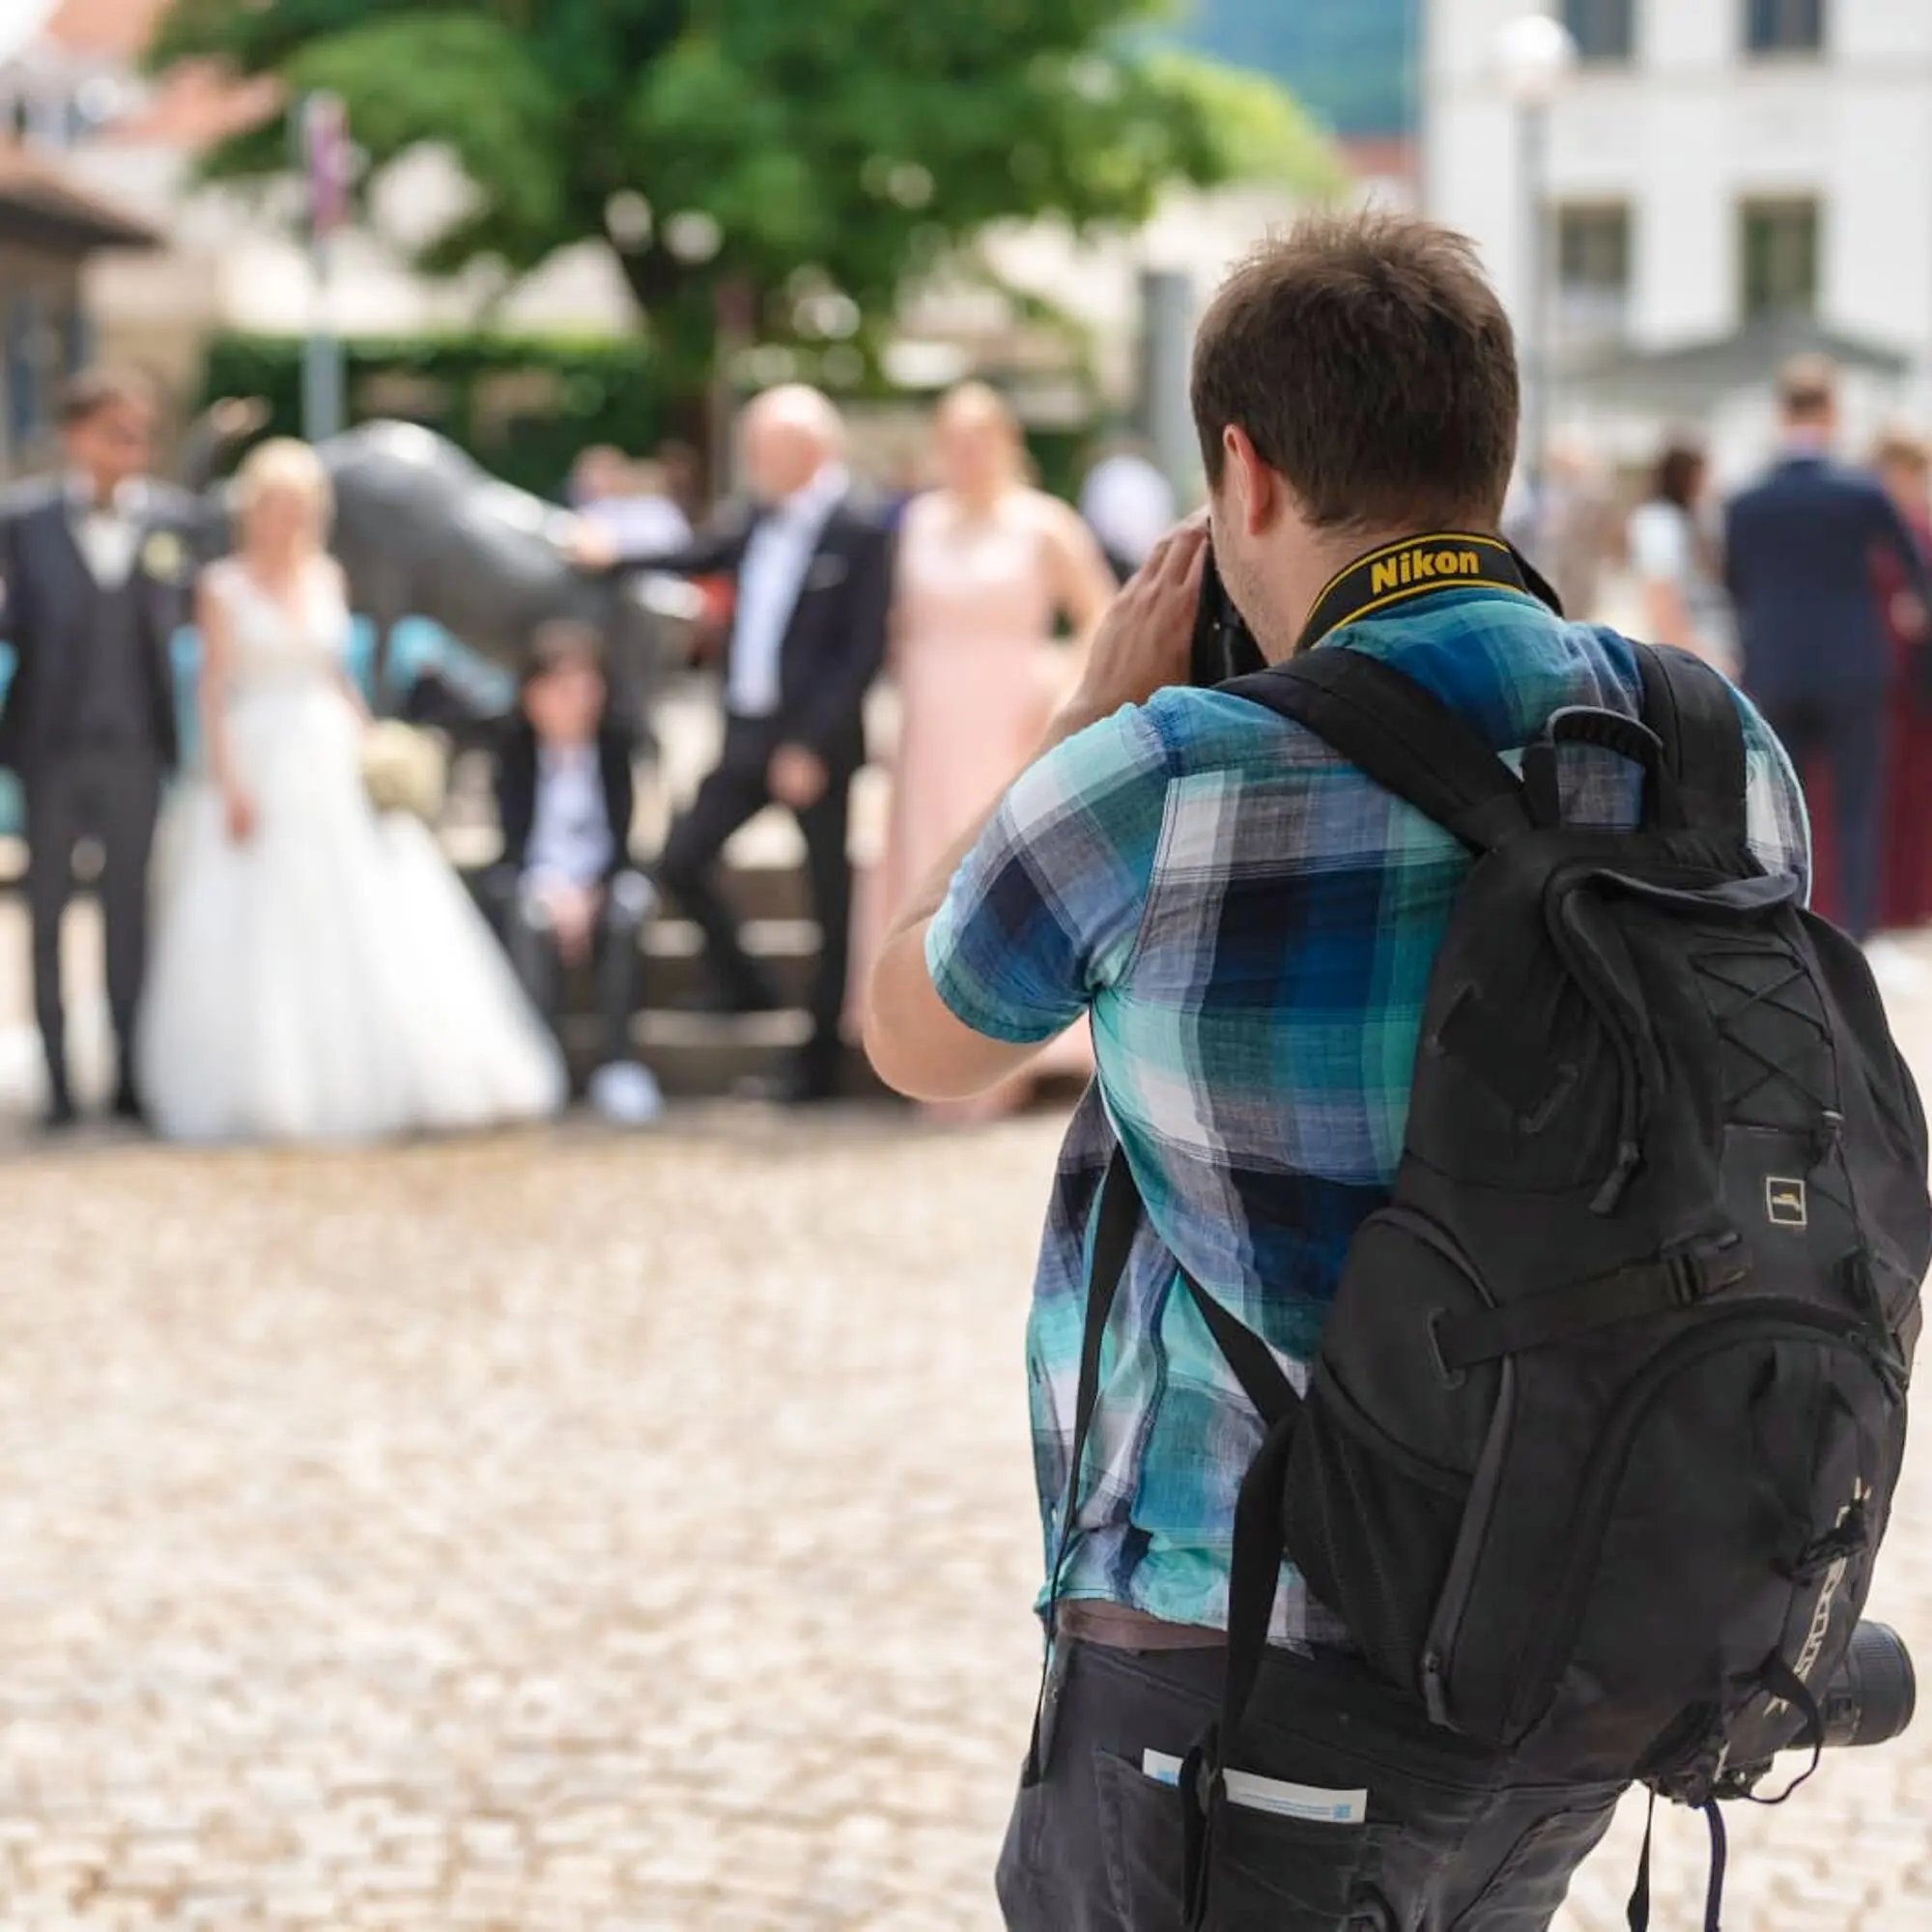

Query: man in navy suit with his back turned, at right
[1725,357,1932,939]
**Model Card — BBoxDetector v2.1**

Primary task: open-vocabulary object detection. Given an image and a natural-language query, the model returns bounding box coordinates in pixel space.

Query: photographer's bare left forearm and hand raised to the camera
[866,526,1208,1099]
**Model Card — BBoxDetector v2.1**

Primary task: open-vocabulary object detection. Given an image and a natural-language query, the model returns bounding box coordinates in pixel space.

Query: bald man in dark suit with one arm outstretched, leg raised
[595,384,893,1101]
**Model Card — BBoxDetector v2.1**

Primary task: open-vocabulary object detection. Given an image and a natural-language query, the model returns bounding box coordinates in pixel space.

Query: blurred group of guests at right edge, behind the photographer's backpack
[1513,357,1932,956]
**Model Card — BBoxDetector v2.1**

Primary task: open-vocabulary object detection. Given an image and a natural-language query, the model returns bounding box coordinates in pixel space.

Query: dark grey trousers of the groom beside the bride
[21,746,162,1099]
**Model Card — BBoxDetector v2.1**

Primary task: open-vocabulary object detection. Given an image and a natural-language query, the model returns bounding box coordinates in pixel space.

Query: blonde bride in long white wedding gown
[137,440,564,1140]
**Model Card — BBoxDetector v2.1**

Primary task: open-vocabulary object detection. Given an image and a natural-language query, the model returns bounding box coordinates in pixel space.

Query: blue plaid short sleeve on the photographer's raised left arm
[925,705,1169,1045]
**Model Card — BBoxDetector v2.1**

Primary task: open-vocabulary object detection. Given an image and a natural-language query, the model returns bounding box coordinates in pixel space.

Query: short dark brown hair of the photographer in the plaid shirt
[1194,211,1520,529]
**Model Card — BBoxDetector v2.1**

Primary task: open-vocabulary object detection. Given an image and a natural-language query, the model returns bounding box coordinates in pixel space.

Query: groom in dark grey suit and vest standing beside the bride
[0,369,197,1128]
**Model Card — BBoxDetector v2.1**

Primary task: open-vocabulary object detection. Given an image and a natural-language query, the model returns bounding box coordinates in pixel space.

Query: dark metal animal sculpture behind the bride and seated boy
[184,402,697,742]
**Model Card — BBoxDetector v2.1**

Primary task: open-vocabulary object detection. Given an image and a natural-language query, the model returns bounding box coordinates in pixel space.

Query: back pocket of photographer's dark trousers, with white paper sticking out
[1094,1752,1372,1932]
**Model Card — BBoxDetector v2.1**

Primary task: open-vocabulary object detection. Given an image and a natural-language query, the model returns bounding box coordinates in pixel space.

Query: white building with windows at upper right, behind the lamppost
[1422,0,1932,468]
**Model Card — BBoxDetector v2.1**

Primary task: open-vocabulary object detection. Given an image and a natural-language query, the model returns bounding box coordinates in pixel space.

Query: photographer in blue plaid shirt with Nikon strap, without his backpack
[867,204,1808,1932]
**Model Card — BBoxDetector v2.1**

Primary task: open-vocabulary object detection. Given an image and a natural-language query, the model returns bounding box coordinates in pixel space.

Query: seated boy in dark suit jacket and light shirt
[487,618,657,1119]
